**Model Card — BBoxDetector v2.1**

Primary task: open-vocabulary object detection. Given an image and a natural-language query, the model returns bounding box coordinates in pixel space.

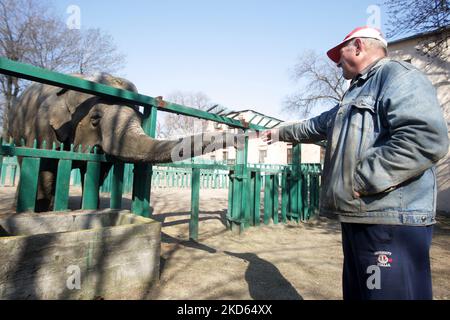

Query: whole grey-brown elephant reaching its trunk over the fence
[7,73,243,212]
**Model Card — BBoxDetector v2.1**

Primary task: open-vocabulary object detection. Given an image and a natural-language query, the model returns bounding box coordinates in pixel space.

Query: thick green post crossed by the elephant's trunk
[132,106,157,217]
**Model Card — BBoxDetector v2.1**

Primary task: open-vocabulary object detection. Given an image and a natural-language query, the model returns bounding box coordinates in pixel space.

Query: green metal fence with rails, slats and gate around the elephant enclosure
[0,58,320,240]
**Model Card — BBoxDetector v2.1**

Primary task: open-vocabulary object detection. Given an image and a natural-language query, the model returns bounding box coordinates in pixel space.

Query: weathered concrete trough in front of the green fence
[0,210,161,300]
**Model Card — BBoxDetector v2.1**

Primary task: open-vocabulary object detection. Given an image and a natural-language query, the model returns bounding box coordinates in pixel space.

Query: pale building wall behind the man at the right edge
[388,32,450,213]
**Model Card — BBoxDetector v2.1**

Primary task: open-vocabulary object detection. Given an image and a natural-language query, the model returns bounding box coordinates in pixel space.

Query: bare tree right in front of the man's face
[283,51,348,118]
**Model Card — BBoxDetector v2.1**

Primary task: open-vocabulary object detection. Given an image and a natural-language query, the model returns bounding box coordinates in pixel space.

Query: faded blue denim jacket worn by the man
[279,58,449,225]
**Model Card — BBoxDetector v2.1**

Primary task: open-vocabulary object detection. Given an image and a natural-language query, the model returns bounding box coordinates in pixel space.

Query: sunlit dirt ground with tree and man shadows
[0,187,450,300]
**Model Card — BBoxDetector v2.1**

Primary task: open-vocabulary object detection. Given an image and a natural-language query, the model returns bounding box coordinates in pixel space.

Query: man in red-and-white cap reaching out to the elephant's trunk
[262,27,449,299]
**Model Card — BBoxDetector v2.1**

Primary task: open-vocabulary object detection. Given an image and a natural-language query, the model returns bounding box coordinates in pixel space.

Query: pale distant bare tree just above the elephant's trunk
[157,91,221,138]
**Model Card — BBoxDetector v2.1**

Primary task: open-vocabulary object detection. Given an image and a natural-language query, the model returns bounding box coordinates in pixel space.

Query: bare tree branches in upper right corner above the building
[384,0,450,57]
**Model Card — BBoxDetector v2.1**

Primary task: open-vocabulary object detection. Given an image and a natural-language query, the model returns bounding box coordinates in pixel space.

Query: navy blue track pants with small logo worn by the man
[341,223,433,300]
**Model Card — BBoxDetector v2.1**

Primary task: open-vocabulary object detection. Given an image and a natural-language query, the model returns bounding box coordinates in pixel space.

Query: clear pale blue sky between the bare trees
[54,0,387,120]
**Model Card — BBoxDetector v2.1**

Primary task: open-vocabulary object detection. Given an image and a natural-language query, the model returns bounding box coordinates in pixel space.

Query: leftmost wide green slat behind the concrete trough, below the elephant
[17,158,41,213]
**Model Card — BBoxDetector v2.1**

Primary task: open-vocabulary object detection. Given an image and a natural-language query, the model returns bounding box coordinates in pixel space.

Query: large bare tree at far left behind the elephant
[0,0,124,136]
